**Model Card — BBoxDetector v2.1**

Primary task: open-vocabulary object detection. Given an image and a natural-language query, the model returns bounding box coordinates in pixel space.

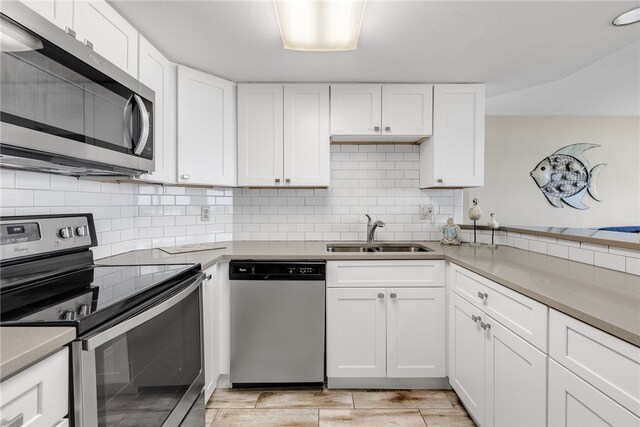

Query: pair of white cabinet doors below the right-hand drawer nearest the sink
[449,270,547,427]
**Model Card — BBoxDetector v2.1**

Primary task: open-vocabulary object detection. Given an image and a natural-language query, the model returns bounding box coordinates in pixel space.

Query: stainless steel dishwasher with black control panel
[229,261,326,387]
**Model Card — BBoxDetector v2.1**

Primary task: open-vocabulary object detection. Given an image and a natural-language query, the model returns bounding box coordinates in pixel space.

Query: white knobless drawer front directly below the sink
[327,261,444,288]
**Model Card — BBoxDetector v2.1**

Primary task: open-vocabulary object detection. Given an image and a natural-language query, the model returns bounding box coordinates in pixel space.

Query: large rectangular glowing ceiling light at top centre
[273,0,366,52]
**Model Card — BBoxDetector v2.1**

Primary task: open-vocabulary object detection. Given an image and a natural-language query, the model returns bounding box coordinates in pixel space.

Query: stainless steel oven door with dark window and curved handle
[72,274,204,427]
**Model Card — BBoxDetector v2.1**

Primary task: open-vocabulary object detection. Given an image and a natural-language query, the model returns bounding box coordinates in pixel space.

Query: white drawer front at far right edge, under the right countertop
[549,310,640,416]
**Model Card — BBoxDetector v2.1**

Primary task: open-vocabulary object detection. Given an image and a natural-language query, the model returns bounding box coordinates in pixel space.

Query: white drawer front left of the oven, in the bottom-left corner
[0,348,69,426]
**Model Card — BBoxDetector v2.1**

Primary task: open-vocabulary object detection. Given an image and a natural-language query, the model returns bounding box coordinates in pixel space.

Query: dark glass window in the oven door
[95,291,202,426]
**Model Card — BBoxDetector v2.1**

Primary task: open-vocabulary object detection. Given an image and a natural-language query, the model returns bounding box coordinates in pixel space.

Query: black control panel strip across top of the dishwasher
[229,261,326,280]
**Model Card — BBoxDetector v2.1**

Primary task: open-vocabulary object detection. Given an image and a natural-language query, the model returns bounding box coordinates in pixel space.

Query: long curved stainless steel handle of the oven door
[82,273,204,351]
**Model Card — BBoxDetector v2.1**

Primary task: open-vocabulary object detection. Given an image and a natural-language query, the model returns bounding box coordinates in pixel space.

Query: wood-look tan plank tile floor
[206,389,475,427]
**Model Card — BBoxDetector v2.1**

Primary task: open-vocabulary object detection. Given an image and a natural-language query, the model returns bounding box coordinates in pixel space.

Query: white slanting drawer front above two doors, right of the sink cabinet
[450,264,548,353]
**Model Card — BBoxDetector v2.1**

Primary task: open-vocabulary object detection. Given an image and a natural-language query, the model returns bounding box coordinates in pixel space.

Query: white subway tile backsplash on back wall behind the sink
[233,144,462,240]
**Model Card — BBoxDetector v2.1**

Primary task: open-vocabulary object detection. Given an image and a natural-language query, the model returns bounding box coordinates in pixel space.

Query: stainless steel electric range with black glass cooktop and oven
[0,214,204,427]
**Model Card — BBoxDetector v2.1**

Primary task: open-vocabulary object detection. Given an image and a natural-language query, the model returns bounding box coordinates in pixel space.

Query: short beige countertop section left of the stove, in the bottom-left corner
[0,326,76,380]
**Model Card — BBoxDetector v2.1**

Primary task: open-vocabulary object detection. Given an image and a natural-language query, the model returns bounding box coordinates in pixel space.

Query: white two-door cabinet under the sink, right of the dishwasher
[327,261,445,379]
